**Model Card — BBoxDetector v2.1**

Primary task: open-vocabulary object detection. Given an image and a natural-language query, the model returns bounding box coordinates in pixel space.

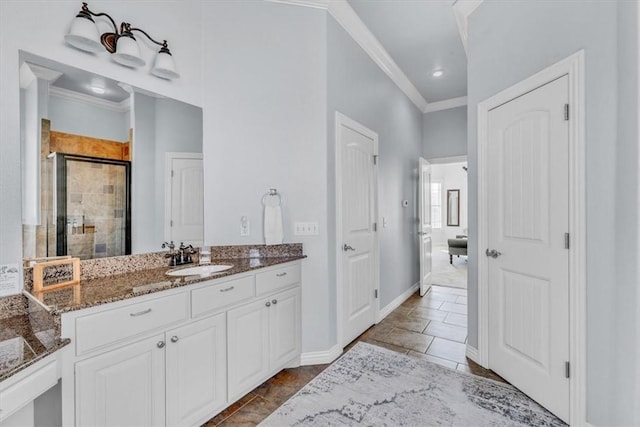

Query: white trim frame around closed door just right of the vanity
[335,111,380,349]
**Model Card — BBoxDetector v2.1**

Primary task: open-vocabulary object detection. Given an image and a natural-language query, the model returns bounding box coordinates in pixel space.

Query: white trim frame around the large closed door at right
[476,50,587,425]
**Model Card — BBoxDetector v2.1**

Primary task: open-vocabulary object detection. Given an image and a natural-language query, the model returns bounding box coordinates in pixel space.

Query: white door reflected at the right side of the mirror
[165,153,204,246]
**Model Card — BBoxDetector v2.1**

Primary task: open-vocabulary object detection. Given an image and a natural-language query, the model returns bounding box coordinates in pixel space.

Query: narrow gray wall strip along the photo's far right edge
[612,2,640,425]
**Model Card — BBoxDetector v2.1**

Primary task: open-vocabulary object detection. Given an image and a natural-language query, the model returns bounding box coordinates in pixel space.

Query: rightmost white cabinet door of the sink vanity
[269,288,302,371]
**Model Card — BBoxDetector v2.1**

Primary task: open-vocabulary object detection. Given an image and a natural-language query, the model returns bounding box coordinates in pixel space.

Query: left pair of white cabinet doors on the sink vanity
[76,314,226,426]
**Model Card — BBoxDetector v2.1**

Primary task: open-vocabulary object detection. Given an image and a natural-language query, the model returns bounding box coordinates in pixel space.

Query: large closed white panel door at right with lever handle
[490,76,569,421]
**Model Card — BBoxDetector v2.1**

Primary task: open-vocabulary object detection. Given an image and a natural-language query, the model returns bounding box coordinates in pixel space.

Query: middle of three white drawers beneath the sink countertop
[191,276,256,317]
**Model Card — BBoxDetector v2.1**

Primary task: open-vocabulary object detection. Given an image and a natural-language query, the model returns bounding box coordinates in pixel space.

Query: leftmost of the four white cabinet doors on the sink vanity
[75,335,165,427]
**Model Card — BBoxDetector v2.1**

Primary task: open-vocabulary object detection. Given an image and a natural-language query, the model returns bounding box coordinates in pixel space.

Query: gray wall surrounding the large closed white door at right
[468,1,637,425]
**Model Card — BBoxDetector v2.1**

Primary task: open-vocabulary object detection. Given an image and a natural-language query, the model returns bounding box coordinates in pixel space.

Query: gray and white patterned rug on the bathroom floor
[260,342,566,427]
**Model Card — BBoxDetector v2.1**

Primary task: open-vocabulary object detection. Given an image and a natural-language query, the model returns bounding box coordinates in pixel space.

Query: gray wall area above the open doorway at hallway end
[422,105,467,159]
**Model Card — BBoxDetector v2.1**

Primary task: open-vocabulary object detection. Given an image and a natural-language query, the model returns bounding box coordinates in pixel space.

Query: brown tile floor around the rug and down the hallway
[205,286,504,427]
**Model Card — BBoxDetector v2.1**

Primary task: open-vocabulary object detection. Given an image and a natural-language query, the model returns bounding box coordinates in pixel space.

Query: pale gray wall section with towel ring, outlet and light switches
[203,1,335,352]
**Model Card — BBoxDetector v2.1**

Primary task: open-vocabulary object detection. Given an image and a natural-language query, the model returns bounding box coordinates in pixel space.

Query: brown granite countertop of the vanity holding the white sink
[25,255,306,316]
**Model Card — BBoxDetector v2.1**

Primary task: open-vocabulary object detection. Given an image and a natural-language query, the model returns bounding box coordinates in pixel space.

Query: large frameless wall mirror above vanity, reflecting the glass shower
[20,52,203,259]
